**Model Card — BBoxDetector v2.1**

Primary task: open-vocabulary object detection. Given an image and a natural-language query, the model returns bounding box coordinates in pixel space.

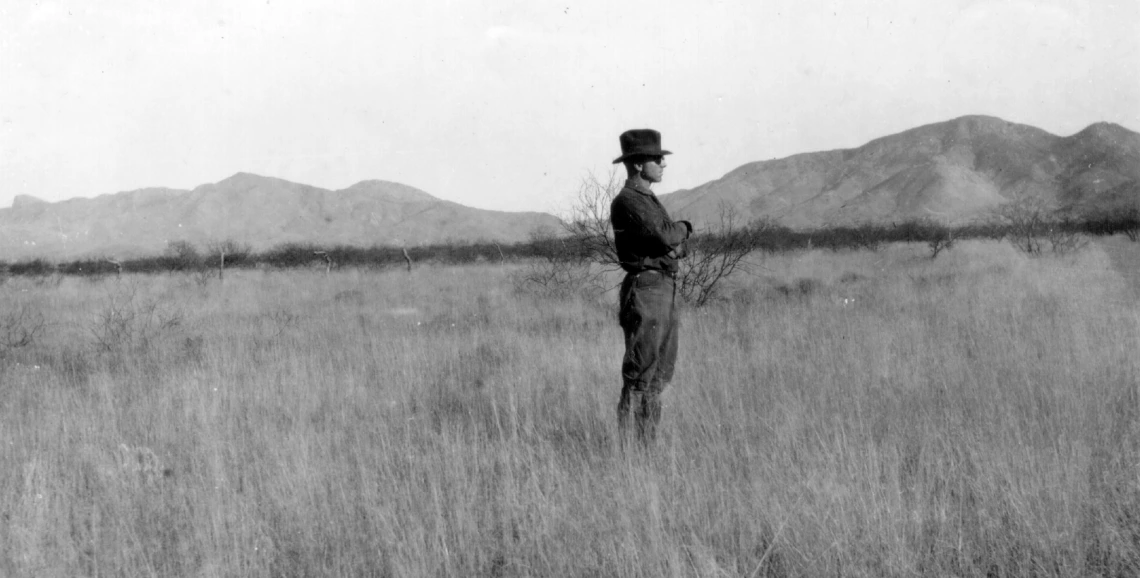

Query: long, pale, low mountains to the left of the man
[0,173,559,260]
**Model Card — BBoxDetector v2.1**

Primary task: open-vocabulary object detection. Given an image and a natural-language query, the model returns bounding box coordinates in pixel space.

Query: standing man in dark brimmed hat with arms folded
[610,129,693,442]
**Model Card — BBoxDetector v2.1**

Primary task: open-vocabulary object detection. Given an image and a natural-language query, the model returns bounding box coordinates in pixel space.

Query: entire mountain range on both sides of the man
[0,116,1140,260]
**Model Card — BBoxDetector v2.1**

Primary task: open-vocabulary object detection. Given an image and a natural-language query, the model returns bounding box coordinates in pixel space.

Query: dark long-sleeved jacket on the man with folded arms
[610,180,693,272]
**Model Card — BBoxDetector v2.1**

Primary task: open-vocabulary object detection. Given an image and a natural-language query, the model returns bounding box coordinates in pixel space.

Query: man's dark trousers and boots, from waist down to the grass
[618,270,681,441]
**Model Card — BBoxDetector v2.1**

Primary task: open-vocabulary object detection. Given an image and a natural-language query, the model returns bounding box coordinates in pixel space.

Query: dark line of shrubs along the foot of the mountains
[0,211,1140,277]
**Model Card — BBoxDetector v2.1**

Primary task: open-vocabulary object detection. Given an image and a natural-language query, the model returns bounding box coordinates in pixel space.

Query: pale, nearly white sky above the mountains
[0,0,1140,211]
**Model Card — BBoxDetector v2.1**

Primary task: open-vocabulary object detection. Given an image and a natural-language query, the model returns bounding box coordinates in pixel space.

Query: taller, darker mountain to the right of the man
[661,116,1140,227]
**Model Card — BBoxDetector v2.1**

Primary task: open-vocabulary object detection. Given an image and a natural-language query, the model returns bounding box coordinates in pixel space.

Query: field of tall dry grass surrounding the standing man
[0,242,1140,577]
